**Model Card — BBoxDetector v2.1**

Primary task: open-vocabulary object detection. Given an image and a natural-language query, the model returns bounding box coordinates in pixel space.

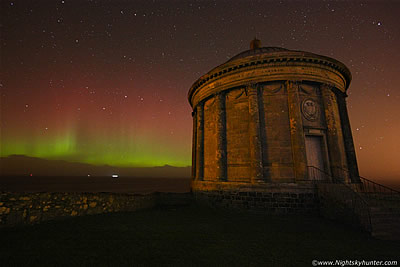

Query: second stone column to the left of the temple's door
[247,84,263,183]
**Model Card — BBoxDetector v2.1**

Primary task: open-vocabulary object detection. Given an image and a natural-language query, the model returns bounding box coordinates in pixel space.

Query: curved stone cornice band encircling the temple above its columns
[188,51,351,106]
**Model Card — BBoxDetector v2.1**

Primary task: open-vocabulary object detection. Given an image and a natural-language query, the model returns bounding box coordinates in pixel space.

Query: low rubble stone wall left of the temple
[0,192,157,226]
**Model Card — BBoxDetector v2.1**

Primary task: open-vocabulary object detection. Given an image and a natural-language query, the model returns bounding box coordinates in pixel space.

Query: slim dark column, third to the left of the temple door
[215,92,227,181]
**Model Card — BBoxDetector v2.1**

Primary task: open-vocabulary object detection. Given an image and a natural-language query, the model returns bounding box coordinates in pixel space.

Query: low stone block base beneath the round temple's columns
[192,181,319,214]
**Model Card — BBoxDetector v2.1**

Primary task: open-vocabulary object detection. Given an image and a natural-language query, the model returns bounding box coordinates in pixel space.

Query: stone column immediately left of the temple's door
[286,81,307,180]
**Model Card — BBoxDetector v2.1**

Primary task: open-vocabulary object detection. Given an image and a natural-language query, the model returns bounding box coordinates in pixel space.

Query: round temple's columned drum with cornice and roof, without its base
[188,47,359,185]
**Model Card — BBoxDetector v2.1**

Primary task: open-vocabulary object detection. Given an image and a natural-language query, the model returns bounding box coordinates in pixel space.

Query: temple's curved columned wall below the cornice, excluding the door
[192,81,351,183]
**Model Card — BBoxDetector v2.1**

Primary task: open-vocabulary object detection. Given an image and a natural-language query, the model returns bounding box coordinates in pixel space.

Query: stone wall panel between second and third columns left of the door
[226,88,250,182]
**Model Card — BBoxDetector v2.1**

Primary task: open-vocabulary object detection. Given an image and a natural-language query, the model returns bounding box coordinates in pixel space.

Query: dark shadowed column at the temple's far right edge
[336,92,360,183]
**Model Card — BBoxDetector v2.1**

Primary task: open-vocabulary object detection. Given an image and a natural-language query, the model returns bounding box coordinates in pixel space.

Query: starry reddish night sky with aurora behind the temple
[0,0,400,182]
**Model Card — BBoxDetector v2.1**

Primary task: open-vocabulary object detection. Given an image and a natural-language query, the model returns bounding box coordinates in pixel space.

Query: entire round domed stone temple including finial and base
[188,39,400,238]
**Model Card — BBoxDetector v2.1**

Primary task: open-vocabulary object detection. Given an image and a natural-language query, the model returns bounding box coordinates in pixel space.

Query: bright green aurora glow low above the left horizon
[1,131,191,167]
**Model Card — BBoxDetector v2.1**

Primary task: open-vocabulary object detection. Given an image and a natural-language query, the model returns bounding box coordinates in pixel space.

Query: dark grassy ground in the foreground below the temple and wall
[0,206,400,266]
